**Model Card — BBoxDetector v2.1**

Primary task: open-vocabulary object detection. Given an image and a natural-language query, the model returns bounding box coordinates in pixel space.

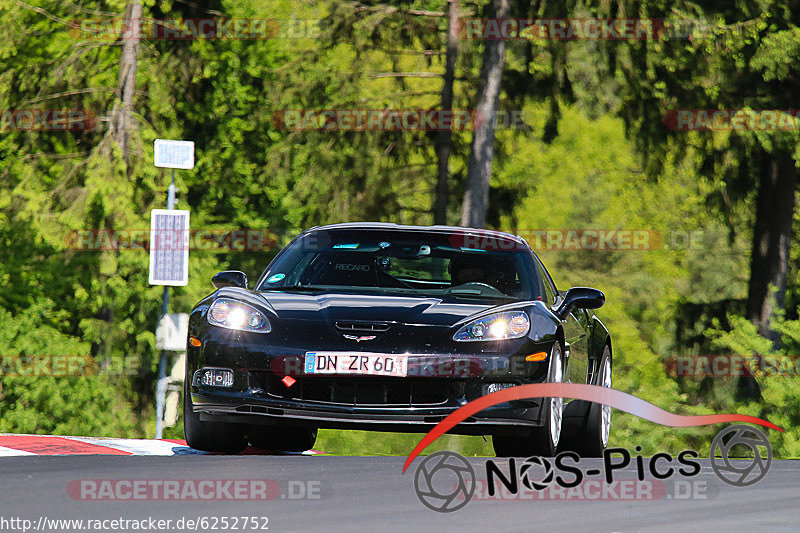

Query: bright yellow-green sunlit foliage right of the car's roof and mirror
[495,106,800,456]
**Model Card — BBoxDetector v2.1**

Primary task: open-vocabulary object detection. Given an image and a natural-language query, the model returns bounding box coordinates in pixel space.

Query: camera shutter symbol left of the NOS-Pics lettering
[414,451,476,513]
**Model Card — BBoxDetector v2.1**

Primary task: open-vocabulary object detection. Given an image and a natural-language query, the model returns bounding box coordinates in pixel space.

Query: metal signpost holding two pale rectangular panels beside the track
[150,139,194,439]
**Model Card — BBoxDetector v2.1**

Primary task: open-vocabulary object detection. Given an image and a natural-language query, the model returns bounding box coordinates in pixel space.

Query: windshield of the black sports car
[258,230,540,300]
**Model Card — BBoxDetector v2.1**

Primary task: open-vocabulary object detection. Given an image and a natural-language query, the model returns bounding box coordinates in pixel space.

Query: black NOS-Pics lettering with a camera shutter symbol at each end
[414,425,772,513]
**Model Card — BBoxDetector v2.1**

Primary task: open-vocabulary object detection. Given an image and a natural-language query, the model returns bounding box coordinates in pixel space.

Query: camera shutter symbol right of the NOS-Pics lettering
[709,424,772,487]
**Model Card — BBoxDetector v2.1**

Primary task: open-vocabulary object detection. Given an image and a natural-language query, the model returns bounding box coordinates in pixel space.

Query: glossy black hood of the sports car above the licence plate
[206,288,556,354]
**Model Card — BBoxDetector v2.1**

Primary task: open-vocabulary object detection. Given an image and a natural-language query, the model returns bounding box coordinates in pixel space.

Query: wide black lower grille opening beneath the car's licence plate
[249,372,451,407]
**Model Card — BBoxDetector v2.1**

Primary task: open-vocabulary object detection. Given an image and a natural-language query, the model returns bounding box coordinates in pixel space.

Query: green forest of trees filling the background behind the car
[0,0,800,457]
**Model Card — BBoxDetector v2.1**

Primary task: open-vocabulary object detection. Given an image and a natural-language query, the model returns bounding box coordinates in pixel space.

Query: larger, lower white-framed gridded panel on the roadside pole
[150,209,189,286]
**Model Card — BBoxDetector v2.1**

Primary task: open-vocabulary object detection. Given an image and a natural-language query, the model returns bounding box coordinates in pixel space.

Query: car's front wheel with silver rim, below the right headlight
[492,341,564,457]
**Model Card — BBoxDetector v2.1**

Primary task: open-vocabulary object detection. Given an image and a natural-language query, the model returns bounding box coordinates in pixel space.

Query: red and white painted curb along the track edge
[0,433,322,457]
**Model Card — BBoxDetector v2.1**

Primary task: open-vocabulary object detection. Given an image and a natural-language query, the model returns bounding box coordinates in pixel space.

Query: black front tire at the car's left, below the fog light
[183,379,247,453]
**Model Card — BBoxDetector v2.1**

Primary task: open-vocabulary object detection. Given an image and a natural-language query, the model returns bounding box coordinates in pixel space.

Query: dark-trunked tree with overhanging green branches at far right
[596,0,800,395]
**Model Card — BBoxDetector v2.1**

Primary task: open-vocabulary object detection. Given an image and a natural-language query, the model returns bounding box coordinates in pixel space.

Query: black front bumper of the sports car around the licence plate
[187,334,549,435]
